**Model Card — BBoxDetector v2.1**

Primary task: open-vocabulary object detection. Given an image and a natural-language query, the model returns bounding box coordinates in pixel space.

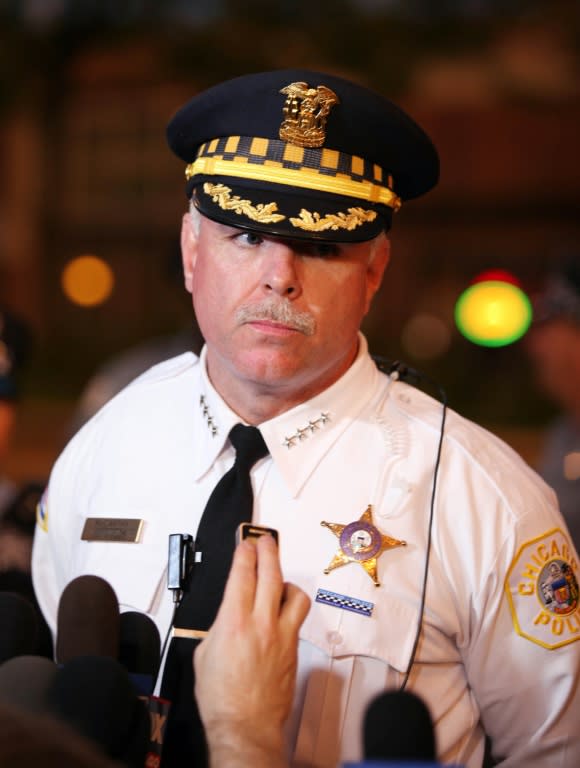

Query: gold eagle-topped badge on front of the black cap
[279,83,339,147]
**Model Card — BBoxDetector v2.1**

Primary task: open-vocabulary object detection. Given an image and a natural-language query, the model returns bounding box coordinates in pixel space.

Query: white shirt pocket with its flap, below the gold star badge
[288,583,419,768]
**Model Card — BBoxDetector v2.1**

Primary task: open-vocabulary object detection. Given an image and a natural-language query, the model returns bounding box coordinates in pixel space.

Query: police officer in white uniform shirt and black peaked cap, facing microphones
[33,70,580,768]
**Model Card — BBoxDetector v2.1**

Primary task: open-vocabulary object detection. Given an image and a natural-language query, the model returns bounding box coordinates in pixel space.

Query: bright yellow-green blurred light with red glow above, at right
[455,280,532,347]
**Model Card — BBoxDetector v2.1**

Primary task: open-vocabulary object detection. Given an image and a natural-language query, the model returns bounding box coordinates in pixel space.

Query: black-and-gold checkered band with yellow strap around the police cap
[185,136,400,210]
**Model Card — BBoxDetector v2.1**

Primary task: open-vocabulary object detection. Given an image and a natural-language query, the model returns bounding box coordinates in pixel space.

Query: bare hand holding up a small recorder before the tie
[194,536,310,768]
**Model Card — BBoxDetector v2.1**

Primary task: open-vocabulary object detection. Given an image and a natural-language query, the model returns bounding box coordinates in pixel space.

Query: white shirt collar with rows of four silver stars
[194,334,384,496]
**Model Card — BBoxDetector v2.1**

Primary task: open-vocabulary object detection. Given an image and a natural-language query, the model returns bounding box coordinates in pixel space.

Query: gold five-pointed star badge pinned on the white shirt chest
[320,504,407,587]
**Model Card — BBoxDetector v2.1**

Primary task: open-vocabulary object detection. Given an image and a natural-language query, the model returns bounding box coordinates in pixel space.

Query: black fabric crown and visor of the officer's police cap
[167,69,439,241]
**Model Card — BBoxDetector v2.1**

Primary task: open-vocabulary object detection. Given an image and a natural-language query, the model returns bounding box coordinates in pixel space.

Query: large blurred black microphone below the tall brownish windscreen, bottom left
[48,656,151,768]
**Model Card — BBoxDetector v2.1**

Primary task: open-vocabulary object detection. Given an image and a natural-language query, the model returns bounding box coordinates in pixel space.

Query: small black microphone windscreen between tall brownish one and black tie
[118,611,161,680]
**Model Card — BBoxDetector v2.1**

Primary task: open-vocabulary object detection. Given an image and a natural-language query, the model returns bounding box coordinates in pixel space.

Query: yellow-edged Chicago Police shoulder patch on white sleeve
[505,528,580,650]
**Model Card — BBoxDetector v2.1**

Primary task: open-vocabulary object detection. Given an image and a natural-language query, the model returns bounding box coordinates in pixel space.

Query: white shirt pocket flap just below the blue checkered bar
[300,593,419,672]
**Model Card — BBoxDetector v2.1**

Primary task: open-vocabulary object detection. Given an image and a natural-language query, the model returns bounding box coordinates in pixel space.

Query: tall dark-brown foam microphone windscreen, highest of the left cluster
[55,576,119,664]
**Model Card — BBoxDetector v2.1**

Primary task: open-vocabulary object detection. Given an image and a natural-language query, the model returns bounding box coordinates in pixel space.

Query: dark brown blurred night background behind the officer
[0,0,580,479]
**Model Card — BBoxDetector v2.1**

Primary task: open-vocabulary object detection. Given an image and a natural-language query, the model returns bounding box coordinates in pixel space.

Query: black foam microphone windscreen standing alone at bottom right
[363,691,436,762]
